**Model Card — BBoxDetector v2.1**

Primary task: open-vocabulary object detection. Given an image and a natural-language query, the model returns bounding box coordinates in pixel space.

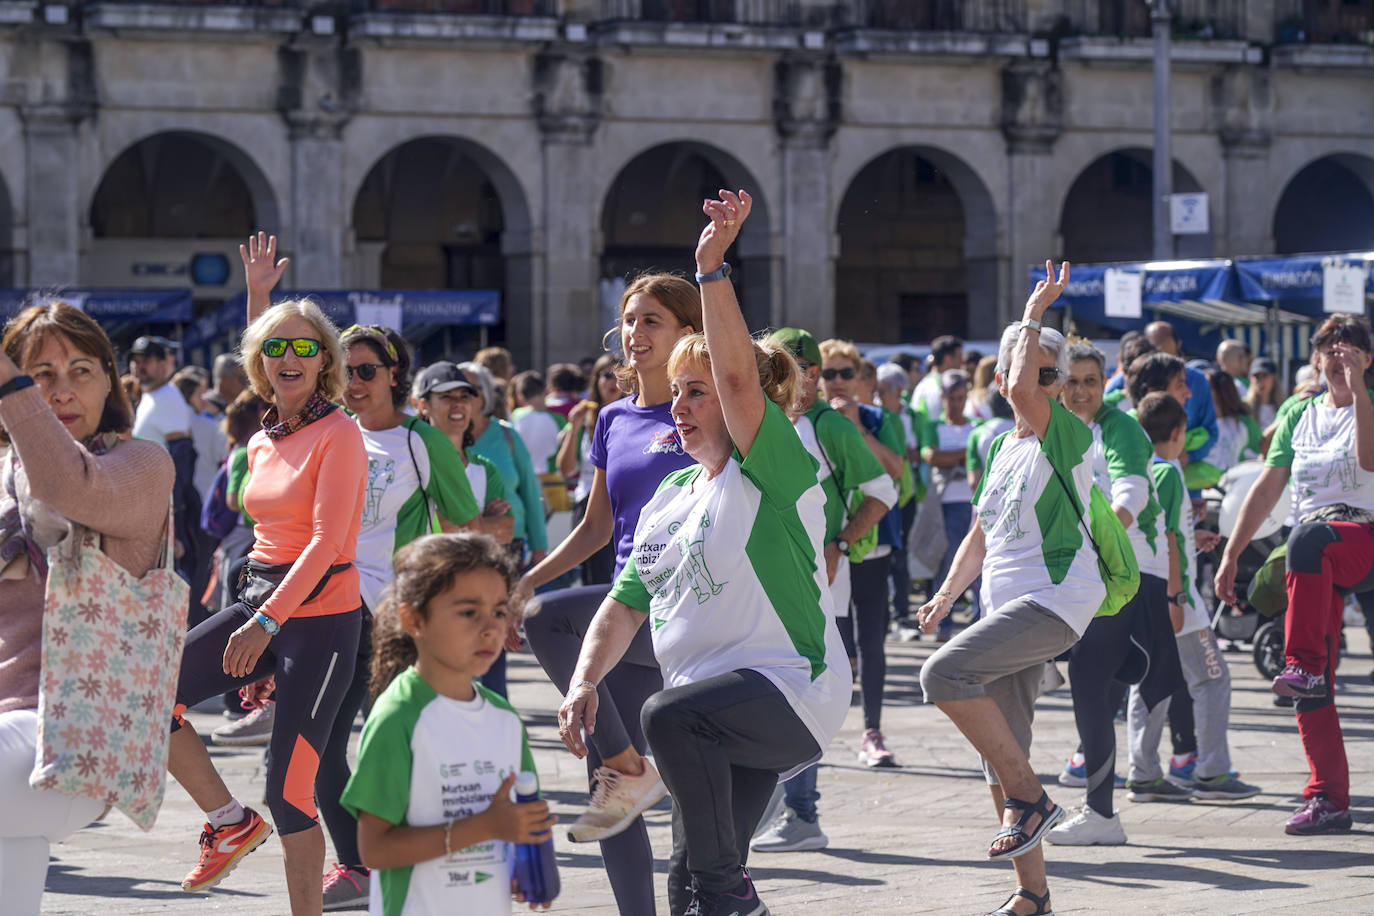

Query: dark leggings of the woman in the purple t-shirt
[525,585,659,916]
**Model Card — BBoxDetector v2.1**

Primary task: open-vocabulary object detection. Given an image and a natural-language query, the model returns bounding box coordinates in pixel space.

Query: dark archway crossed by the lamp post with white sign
[1059,148,1212,264]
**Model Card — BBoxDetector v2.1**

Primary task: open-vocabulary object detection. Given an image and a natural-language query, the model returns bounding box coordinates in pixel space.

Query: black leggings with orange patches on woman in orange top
[172,602,361,836]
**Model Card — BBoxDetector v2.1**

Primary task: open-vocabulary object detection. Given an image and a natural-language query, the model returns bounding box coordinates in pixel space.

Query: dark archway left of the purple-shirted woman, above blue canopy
[353,136,532,367]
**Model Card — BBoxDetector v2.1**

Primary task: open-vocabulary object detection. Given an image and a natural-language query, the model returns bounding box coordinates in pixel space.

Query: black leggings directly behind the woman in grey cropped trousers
[1069,579,1149,817]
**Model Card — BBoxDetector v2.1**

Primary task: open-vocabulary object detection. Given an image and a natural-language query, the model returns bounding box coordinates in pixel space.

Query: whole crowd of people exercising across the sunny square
[0,191,1374,916]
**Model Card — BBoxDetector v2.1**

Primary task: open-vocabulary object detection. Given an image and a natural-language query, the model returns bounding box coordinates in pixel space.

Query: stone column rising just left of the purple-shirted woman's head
[533,47,606,367]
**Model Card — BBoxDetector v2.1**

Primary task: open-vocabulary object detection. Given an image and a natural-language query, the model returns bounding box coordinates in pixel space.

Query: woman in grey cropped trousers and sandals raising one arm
[919,261,1106,916]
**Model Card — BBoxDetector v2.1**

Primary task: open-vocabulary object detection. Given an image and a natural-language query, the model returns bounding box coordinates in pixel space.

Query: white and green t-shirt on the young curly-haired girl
[341,667,534,916]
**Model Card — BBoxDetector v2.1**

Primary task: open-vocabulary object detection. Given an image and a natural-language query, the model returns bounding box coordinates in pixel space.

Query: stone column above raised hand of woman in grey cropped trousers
[1005,60,1063,328]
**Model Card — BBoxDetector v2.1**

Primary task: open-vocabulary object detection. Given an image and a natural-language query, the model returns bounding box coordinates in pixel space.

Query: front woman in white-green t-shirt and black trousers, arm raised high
[558,191,851,916]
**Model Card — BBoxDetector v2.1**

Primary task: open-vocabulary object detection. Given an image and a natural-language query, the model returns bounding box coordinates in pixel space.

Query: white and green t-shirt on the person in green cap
[796,398,897,617]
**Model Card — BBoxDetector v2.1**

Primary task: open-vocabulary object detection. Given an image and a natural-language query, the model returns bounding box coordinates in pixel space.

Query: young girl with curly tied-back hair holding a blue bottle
[342,534,556,916]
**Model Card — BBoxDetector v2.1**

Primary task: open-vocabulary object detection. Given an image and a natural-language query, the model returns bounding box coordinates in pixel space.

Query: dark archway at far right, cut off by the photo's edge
[1274,154,1374,254]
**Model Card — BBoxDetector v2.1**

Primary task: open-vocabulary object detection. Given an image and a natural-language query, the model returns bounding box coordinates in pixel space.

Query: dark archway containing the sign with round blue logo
[81,130,280,349]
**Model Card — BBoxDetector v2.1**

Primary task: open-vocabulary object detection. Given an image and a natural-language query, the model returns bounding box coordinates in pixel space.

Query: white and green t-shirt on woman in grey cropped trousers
[973,401,1106,636]
